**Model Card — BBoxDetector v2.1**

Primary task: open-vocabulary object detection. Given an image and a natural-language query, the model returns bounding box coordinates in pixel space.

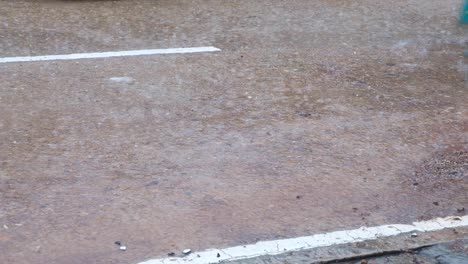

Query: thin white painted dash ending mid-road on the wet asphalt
[0,47,221,63]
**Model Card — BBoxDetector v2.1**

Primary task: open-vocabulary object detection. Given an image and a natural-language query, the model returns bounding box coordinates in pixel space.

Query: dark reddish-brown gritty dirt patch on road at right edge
[395,144,468,223]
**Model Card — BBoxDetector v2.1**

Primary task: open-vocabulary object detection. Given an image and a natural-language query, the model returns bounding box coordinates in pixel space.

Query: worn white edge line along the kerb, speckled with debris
[139,215,468,264]
